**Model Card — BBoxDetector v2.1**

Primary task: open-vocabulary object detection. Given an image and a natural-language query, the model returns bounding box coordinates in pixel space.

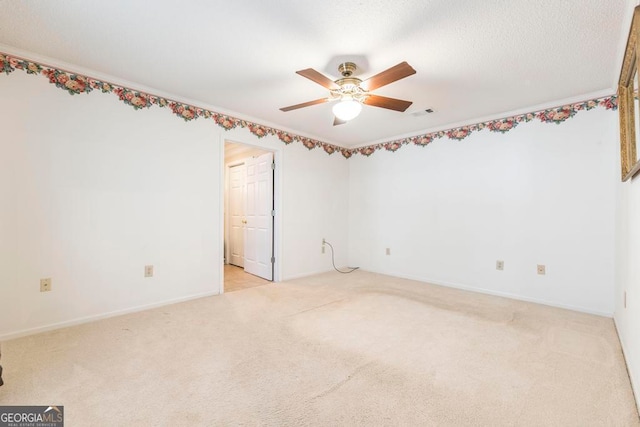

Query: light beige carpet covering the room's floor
[0,271,640,426]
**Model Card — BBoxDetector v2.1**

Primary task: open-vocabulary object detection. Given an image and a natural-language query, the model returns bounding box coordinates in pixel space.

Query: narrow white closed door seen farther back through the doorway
[229,164,246,267]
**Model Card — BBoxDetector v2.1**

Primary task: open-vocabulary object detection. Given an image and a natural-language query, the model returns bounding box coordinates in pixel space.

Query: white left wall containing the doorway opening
[0,71,348,340]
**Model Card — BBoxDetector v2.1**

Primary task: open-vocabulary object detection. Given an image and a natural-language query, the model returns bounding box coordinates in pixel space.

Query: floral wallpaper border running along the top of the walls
[0,52,618,159]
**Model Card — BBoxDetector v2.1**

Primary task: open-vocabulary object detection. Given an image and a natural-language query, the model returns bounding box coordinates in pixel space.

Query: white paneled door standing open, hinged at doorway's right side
[244,153,273,280]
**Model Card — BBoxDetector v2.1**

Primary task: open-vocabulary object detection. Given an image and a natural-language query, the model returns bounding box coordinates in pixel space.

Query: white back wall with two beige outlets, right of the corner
[349,109,619,315]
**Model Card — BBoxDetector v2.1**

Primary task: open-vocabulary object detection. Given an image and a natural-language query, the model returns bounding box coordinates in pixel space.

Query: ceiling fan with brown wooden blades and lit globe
[280,62,416,126]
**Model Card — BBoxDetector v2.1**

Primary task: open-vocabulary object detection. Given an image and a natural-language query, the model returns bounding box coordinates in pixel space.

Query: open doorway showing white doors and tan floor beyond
[223,142,275,292]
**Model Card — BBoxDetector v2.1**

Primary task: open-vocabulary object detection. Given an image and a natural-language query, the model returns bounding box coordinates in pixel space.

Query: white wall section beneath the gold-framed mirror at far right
[614,169,640,406]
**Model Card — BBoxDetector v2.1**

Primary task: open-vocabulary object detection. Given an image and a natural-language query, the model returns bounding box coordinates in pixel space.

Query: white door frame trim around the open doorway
[218,135,284,294]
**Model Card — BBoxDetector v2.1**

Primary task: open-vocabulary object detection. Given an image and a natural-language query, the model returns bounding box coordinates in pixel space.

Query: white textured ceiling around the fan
[0,0,637,146]
